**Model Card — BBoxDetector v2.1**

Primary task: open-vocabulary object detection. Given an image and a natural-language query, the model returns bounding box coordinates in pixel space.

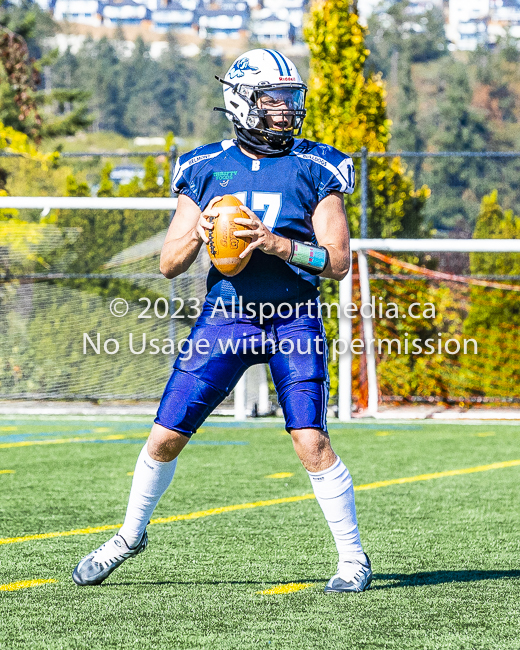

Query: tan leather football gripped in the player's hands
[207,194,255,277]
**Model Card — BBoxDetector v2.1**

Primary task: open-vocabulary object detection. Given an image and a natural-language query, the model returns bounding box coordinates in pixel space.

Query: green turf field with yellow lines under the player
[0,417,520,650]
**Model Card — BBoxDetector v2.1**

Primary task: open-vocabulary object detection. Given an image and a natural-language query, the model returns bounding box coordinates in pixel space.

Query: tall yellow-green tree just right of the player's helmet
[304,0,428,400]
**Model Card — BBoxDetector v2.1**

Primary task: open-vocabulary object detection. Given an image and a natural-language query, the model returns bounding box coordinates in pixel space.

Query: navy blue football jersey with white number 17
[172,139,355,306]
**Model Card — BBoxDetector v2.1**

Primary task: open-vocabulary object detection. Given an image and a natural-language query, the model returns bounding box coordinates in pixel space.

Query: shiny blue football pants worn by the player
[155,304,329,437]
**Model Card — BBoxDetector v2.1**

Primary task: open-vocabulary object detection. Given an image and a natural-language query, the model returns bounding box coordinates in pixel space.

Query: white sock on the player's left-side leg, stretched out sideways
[119,444,177,548]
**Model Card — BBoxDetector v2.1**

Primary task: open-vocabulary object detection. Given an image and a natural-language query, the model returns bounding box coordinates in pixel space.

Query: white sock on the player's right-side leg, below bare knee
[308,458,364,563]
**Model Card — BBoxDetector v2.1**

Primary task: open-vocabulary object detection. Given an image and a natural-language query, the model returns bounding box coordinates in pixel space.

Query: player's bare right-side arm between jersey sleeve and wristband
[312,191,350,280]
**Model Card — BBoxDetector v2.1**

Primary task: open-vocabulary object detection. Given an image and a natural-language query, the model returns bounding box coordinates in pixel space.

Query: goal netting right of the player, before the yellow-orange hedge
[335,242,520,411]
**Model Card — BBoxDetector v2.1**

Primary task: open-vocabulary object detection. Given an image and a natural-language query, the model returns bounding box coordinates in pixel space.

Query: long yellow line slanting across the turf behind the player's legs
[0,460,520,545]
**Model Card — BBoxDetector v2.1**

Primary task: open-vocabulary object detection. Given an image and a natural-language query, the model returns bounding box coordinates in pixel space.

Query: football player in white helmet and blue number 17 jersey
[73,49,372,592]
